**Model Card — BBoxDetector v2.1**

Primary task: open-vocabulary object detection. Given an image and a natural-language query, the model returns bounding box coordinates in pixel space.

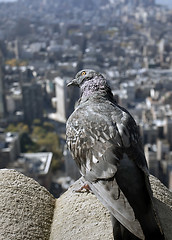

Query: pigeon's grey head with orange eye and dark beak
[67,69,101,87]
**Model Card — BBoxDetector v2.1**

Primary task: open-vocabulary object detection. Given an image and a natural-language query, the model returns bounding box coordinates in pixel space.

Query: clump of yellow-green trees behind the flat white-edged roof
[6,119,62,171]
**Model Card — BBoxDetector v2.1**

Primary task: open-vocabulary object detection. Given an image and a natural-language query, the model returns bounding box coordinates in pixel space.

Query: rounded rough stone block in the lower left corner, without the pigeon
[0,169,55,240]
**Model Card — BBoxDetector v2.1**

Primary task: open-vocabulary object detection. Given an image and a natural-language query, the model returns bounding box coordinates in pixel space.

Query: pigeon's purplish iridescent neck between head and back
[80,76,112,98]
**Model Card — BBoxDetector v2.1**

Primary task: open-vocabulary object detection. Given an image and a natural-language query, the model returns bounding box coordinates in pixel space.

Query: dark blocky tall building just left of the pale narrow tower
[22,83,43,125]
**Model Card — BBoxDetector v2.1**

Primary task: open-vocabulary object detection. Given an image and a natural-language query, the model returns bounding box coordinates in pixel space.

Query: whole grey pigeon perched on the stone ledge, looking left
[66,69,165,240]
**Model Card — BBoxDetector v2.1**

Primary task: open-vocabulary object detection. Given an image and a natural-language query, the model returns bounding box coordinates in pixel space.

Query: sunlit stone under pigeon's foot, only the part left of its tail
[50,179,113,240]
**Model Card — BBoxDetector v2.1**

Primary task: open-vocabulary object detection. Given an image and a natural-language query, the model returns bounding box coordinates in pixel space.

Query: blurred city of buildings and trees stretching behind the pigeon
[0,0,172,197]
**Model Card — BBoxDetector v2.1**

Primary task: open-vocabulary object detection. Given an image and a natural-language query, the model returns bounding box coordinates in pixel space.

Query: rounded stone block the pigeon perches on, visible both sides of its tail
[50,176,172,240]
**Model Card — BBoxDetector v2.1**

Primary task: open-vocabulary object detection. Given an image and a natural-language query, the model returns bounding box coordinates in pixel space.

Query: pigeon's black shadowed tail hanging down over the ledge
[115,155,165,240]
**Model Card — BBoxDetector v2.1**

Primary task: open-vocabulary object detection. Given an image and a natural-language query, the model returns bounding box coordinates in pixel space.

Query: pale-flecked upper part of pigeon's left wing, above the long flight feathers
[66,108,122,181]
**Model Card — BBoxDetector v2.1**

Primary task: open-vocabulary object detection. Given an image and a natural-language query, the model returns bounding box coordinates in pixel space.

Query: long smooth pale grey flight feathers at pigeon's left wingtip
[89,178,145,240]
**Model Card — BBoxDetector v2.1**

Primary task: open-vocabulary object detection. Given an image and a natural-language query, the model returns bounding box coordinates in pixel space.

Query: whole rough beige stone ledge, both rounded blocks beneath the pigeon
[0,170,172,240]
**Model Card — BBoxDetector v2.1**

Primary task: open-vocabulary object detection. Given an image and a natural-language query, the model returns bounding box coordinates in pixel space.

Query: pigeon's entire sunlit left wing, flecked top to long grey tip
[66,108,144,239]
